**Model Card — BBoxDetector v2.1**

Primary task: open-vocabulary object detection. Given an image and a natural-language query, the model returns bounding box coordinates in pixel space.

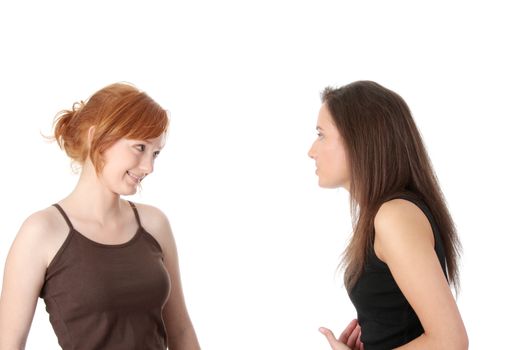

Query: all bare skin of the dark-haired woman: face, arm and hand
[308,104,468,350]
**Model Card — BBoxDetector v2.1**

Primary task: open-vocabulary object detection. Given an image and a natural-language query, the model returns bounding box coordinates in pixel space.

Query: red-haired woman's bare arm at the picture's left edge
[0,212,47,350]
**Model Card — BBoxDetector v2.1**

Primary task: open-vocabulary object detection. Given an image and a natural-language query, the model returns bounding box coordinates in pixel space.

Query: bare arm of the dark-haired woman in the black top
[374,199,468,350]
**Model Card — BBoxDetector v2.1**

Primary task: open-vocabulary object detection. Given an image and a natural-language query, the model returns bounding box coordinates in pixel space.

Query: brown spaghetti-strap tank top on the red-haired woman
[40,202,170,350]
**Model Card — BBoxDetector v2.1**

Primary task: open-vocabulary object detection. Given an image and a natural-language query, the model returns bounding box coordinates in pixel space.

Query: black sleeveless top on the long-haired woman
[349,194,446,350]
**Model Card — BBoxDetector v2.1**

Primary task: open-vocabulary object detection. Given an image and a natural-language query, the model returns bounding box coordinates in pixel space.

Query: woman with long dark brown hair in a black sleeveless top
[308,81,468,350]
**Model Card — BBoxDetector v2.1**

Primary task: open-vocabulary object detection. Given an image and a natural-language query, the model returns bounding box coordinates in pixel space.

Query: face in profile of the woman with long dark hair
[308,103,350,190]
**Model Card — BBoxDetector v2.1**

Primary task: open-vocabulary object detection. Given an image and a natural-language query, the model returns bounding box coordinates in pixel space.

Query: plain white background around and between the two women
[0,0,525,349]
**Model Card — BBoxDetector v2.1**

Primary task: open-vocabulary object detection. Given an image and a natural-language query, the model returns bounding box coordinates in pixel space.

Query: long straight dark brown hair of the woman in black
[322,81,461,290]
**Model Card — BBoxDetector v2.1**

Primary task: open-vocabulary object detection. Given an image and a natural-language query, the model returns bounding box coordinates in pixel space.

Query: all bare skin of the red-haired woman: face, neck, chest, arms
[0,129,200,350]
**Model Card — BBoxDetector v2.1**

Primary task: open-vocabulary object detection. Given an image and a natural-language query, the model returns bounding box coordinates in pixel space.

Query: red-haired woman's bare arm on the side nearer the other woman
[139,205,200,350]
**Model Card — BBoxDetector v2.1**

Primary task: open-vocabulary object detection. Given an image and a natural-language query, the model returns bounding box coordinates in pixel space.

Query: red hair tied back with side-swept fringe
[54,83,169,174]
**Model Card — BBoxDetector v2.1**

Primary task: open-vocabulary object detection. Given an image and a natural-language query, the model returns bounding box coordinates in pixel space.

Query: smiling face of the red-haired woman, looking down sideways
[99,133,166,195]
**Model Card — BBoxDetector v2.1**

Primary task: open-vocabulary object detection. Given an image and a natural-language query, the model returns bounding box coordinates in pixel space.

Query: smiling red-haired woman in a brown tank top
[0,83,199,350]
